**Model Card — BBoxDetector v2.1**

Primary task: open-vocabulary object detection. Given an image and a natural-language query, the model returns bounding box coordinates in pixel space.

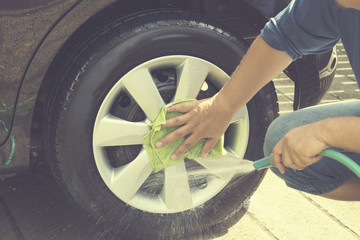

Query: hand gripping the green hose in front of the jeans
[273,122,330,174]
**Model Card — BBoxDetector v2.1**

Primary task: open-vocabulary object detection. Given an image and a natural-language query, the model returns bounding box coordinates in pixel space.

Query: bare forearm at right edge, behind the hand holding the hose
[319,117,360,153]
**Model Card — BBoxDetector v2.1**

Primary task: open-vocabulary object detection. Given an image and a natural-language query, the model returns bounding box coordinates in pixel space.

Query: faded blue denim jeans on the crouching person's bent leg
[264,100,360,195]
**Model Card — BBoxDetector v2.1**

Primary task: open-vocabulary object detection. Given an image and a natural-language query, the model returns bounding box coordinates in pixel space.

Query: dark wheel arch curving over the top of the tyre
[28,0,276,145]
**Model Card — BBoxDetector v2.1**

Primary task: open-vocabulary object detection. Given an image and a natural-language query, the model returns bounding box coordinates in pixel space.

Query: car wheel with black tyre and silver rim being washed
[44,10,278,239]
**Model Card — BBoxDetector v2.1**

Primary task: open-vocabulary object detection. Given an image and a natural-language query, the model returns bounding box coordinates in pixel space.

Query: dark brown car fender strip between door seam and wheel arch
[0,0,115,174]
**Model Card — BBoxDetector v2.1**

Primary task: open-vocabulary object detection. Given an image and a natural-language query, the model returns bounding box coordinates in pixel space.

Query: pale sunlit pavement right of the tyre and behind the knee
[216,44,360,240]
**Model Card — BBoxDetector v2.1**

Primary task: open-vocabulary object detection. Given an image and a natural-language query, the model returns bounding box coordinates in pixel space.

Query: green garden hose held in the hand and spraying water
[253,148,360,178]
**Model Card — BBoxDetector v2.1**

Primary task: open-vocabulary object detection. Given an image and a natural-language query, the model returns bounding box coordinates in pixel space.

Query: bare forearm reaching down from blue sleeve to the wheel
[215,36,292,113]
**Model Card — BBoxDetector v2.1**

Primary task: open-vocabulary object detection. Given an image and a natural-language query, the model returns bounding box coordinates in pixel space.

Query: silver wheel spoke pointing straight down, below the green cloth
[162,161,192,209]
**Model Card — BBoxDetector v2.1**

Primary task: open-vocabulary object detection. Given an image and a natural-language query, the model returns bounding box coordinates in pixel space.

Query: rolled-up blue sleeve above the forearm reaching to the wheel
[261,0,340,60]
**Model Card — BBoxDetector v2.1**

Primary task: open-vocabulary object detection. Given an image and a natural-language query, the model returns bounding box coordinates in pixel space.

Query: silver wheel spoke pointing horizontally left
[94,115,149,146]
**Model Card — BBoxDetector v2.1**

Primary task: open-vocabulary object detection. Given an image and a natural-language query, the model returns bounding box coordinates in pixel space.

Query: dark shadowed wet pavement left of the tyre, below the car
[0,165,117,240]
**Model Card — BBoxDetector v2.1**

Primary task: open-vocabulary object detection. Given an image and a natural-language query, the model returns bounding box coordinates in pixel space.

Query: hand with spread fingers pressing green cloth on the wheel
[156,95,234,160]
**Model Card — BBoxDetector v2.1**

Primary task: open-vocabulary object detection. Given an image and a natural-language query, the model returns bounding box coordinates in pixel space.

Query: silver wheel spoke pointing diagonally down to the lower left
[111,150,153,201]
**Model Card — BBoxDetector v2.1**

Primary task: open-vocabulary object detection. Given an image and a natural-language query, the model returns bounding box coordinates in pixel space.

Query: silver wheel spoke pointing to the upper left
[122,68,165,121]
